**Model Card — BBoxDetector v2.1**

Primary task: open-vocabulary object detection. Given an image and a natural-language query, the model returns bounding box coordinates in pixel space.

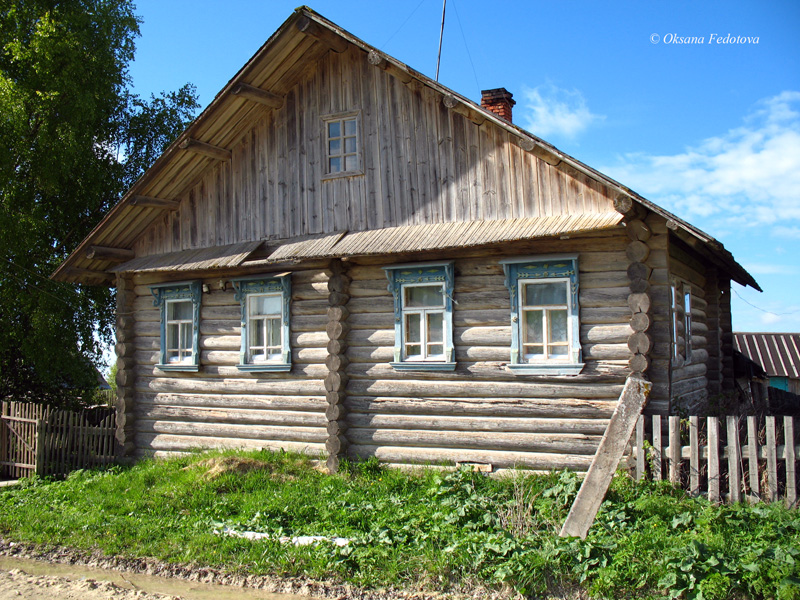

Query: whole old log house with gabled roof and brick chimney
[54,7,758,470]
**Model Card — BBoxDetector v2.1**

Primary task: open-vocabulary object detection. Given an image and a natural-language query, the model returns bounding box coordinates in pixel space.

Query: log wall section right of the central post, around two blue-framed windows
[346,231,633,471]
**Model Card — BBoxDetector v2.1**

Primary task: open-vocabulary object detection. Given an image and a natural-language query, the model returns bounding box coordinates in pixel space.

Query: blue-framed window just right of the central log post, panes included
[384,261,456,371]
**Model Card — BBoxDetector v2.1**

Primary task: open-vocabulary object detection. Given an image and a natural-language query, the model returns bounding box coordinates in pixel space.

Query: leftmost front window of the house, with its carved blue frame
[150,281,201,371]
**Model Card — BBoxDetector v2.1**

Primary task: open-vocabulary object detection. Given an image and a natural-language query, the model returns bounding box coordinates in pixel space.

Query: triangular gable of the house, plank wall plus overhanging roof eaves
[54,7,749,290]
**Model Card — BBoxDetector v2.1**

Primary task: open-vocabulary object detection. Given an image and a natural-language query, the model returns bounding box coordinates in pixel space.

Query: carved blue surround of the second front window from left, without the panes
[231,273,292,372]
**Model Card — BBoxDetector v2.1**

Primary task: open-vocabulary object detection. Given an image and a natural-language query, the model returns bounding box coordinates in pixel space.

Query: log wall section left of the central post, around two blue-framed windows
[133,270,329,456]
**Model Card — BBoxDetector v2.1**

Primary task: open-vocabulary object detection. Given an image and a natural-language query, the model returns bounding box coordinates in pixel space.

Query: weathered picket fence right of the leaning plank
[632,416,800,506]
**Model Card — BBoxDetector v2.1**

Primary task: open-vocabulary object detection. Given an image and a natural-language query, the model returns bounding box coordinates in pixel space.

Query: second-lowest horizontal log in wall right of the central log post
[347,427,600,455]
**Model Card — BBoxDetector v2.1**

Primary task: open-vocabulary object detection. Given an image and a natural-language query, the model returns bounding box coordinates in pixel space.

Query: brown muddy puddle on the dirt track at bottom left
[0,555,318,600]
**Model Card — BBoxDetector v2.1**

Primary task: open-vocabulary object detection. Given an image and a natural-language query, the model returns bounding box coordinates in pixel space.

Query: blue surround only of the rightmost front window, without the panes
[500,255,583,375]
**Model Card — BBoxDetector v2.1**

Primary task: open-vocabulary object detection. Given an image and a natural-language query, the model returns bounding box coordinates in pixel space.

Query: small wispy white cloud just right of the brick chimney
[522,83,605,138]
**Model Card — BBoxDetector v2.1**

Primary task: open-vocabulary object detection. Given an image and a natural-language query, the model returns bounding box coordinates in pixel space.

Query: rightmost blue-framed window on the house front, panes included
[500,256,583,375]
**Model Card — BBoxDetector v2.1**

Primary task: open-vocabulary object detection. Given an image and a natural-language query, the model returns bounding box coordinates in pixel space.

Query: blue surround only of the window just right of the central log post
[383,261,456,371]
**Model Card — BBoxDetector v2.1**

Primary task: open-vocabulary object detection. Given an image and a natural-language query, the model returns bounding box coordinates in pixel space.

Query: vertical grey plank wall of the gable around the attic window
[135,48,612,256]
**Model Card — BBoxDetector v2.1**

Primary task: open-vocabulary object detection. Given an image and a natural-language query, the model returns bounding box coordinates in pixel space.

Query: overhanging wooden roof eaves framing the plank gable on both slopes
[53,6,760,289]
